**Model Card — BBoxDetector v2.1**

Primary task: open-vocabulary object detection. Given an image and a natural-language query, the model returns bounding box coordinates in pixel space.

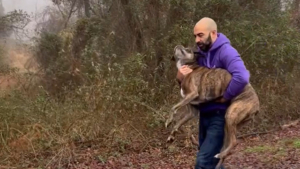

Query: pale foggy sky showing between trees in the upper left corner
[2,0,52,40]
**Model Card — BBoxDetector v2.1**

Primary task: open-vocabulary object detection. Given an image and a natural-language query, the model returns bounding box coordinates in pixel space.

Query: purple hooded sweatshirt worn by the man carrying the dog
[198,33,250,112]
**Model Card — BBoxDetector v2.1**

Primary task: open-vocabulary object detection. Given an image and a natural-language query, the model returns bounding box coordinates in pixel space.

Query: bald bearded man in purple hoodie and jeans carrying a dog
[176,17,250,169]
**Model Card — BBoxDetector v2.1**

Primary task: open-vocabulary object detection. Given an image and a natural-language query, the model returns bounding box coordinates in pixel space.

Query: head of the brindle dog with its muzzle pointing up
[172,45,199,69]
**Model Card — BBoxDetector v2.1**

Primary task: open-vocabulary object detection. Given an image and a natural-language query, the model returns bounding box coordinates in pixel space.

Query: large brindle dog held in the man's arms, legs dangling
[165,45,260,169]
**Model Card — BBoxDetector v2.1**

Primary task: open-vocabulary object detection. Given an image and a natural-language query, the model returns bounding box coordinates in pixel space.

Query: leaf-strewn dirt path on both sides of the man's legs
[65,124,300,169]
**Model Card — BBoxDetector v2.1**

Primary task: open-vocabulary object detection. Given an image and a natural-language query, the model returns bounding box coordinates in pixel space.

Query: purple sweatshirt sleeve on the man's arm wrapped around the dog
[220,46,250,100]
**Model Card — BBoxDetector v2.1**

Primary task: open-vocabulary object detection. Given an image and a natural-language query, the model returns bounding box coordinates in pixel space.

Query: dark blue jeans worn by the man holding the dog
[195,110,226,169]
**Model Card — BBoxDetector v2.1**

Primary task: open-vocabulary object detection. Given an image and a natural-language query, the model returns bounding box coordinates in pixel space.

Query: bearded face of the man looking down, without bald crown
[195,32,212,52]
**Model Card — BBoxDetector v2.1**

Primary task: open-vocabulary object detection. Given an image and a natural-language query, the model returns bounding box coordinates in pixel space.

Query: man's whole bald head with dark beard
[194,17,218,51]
